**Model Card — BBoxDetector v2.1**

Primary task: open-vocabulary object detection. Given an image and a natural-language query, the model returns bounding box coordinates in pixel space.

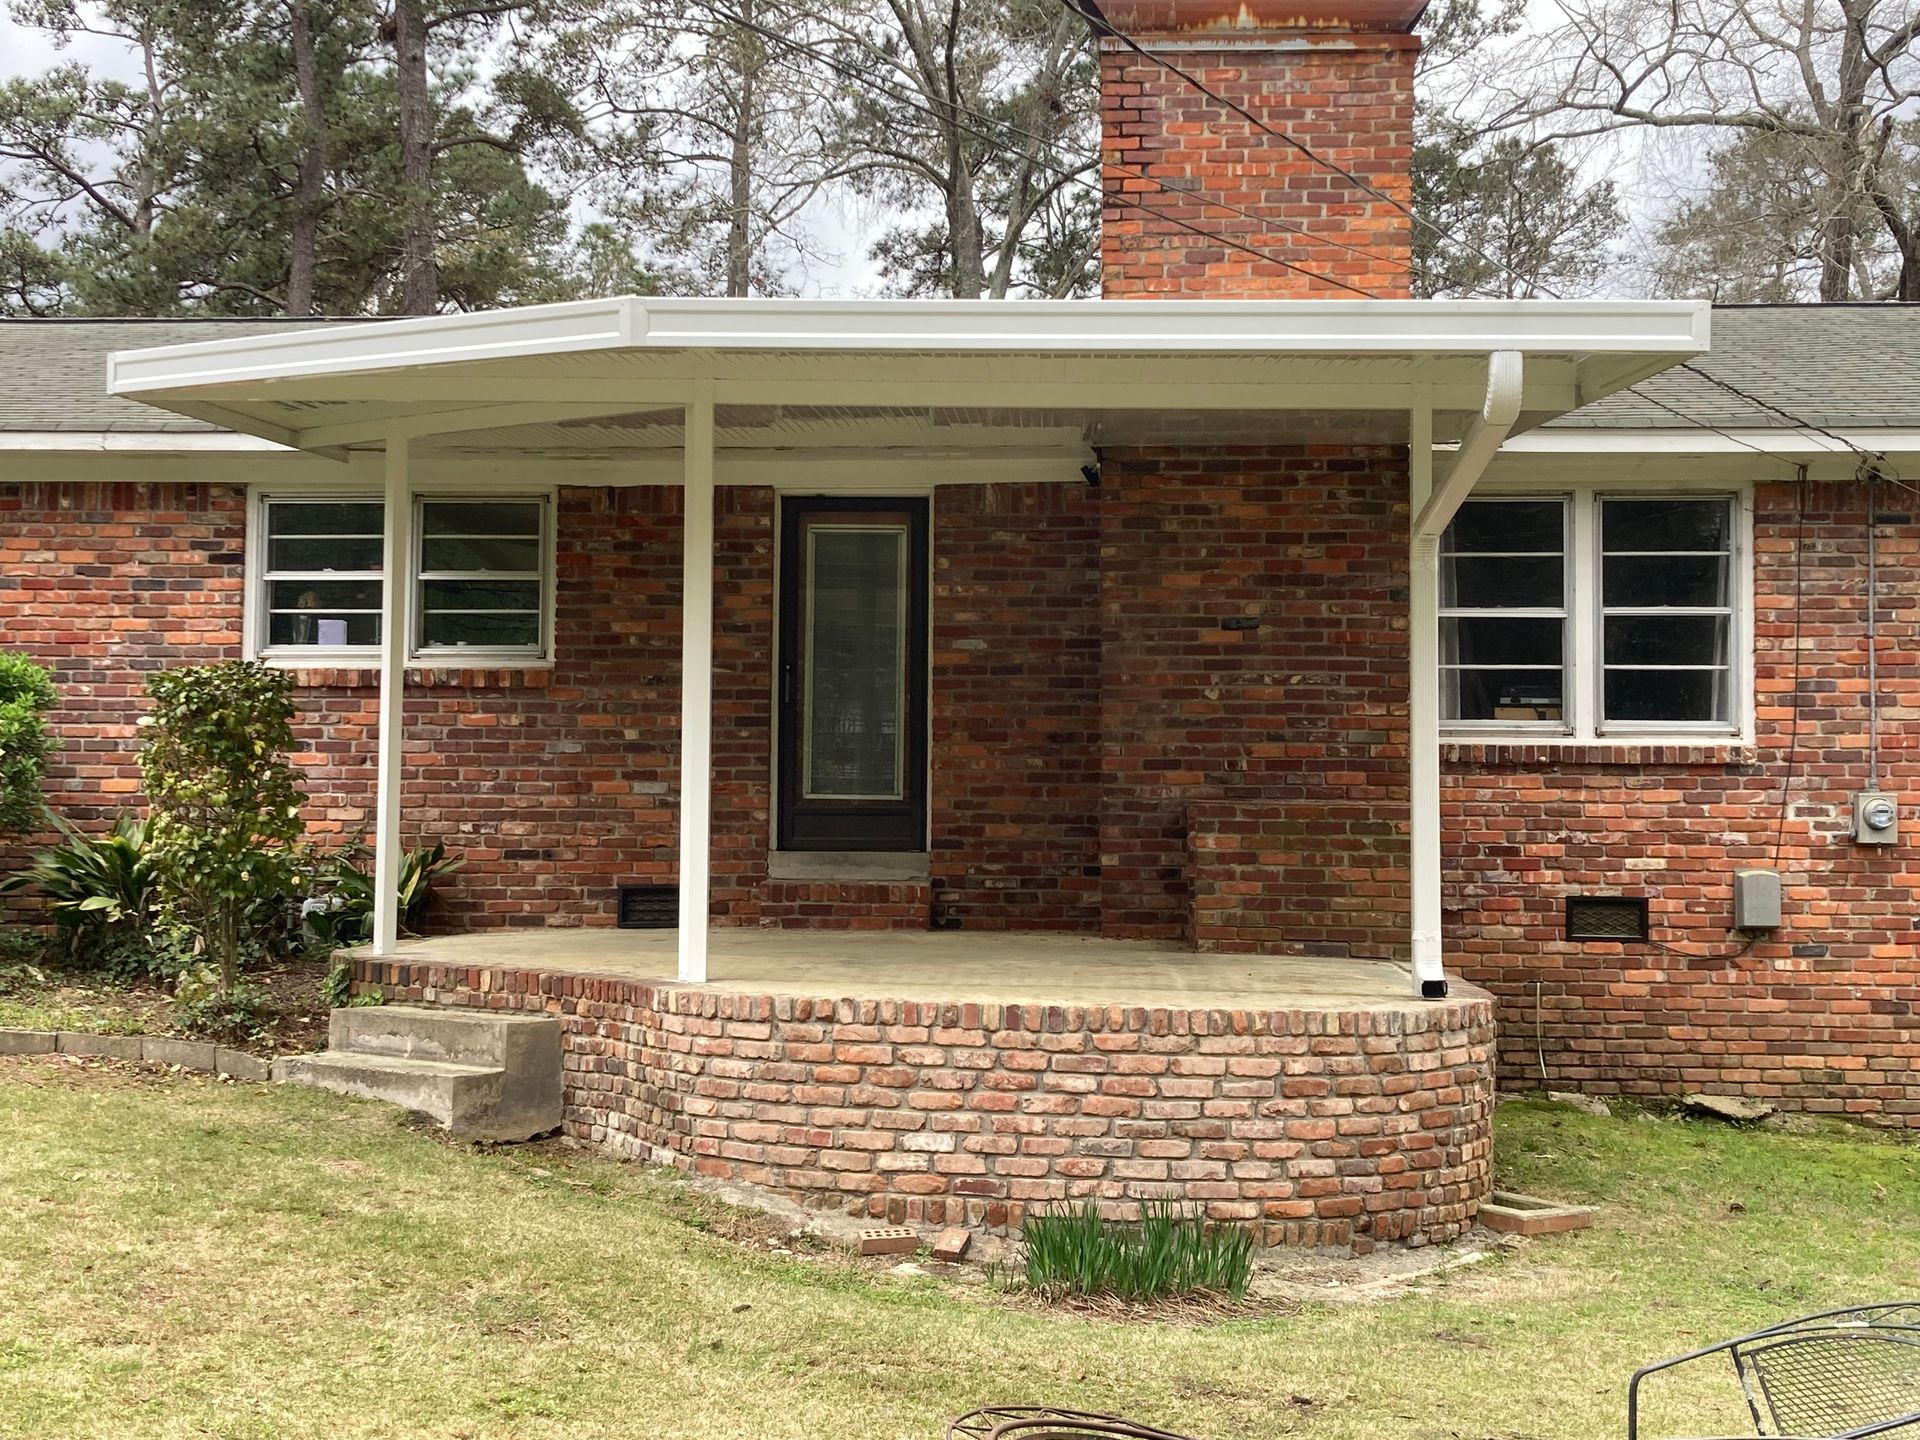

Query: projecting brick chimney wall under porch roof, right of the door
[1100,445,1411,956]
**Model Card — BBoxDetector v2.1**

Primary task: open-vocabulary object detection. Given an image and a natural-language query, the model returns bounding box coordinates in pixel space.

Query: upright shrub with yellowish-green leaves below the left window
[140,660,305,995]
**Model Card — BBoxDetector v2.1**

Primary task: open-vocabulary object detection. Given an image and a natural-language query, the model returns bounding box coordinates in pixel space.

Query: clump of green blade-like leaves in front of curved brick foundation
[1021,1200,1254,1300]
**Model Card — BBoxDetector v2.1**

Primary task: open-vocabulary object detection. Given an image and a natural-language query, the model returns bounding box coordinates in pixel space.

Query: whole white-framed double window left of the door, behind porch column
[246,492,553,664]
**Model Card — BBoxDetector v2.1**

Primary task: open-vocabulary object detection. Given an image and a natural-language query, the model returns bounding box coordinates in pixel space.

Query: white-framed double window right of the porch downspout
[1440,488,1751,739]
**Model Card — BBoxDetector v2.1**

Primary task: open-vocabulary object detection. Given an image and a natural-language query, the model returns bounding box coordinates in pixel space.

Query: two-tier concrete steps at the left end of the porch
[275,1004,561,1140]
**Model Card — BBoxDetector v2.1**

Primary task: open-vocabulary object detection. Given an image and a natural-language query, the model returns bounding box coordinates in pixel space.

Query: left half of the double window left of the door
[250,495,386,659]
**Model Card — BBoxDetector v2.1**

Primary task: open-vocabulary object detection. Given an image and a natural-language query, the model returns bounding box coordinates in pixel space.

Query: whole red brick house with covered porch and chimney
[0,0,1920,1246]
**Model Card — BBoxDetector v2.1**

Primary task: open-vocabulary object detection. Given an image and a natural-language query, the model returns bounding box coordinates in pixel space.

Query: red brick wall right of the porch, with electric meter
[1446,484,1920,1123]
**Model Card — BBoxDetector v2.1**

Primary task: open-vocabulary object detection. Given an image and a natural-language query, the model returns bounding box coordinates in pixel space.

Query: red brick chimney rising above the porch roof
[1100,0,1423,300]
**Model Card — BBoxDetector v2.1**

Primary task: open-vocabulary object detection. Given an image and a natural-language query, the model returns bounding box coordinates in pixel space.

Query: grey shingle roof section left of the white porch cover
[0,321,357,434]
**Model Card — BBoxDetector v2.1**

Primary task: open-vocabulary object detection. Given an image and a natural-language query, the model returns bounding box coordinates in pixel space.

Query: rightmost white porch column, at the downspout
[1407,395,1446,1000]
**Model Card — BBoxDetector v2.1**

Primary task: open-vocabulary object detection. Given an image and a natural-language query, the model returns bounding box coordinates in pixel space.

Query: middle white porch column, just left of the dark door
[680,380,714,985]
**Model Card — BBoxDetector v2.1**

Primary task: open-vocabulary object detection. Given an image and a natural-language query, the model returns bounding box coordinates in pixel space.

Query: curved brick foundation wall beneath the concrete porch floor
[359,960,1494,1250]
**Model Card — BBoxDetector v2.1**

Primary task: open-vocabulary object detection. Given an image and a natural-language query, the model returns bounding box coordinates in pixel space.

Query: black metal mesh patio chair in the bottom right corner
[1626,1300,1920,1440]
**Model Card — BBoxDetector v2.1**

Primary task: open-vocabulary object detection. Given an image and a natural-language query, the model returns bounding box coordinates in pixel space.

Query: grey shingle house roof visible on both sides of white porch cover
[0,305,1920,432]
